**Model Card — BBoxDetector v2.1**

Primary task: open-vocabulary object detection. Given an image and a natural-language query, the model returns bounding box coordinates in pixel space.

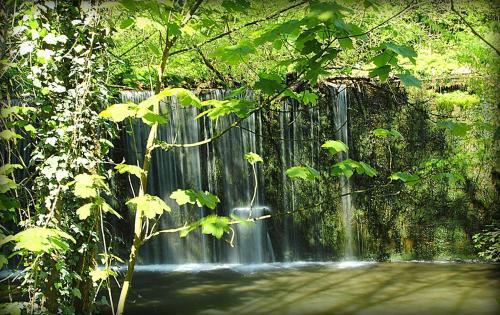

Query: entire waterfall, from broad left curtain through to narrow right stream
[122,85,355,264]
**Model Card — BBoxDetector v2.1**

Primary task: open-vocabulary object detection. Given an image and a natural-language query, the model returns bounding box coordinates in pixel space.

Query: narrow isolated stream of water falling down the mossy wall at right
[331,85,354,260]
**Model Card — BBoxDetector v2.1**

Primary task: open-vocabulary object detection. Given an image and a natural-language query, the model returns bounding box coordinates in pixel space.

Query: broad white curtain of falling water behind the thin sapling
[121,90,274,264]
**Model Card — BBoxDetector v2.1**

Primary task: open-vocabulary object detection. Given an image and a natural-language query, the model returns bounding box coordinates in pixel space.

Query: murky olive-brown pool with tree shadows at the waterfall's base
[122,262,500,315]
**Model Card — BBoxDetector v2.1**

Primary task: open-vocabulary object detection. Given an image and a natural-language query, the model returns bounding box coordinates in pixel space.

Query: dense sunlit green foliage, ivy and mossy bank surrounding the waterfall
[0,0,500,314]
